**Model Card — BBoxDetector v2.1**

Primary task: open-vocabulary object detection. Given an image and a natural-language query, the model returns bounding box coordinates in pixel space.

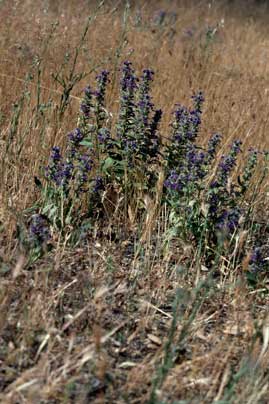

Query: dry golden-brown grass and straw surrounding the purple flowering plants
[0,0,269,404]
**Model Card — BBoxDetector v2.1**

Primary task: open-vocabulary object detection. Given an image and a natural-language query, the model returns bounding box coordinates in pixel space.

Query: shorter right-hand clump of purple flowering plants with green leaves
[161,91,264,266]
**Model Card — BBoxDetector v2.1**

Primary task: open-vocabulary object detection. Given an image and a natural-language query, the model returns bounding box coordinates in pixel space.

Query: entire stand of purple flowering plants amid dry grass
[30,61,268,278]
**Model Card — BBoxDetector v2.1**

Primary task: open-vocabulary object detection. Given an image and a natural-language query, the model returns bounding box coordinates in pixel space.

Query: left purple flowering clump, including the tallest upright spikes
[40,61,162,228]
